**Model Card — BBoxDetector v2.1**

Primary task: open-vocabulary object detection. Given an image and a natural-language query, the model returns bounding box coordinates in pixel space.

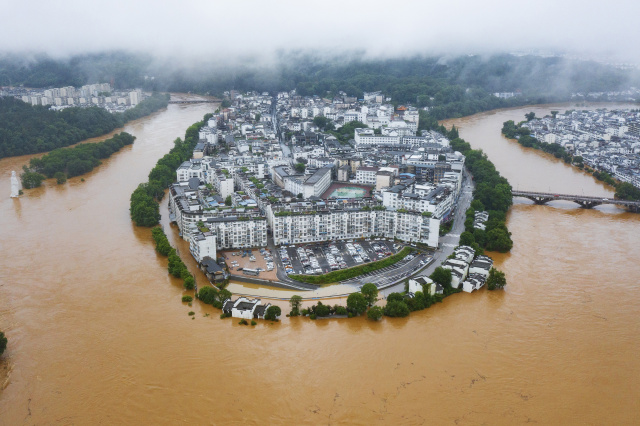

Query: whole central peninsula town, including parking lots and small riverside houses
[162,91,502,319]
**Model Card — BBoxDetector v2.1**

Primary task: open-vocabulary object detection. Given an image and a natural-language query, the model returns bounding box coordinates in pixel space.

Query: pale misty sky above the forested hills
[0,0,640,63]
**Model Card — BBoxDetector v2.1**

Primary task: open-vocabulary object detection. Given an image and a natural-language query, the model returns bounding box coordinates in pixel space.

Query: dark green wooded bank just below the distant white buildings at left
[0,93,170,158]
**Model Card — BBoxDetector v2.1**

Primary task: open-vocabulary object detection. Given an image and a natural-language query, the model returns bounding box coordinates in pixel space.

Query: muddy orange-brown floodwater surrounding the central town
[0,101,640,425]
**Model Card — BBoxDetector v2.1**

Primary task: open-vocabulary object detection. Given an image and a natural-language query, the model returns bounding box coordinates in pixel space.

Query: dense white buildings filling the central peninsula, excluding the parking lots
[169,91,472,278]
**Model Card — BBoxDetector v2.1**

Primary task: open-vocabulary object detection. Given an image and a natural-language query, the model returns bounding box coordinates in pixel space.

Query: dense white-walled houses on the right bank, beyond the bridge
[523,109,640,188]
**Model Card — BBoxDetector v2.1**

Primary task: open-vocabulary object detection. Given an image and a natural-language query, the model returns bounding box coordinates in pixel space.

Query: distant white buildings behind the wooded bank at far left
[2,83,145,112]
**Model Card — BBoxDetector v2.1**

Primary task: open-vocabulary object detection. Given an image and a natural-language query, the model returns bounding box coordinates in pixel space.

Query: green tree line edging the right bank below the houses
[501,111,640,201]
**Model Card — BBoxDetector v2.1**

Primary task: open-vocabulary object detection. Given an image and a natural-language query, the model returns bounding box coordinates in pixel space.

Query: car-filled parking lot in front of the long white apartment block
[278,240,403,274]
